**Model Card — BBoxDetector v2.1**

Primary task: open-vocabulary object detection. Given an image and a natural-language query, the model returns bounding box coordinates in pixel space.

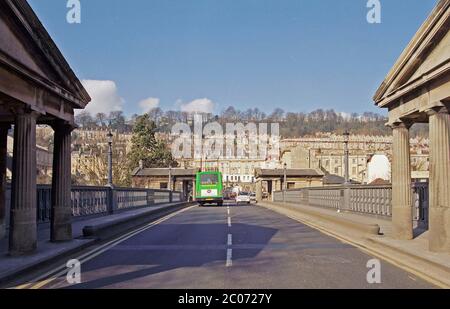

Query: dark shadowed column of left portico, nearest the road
[50,121,73,242]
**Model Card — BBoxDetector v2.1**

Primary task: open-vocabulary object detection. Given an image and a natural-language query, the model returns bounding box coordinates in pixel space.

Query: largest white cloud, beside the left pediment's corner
[78,80,125,115]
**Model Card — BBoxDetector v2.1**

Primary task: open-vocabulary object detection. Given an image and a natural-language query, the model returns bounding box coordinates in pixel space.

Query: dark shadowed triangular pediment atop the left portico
[0,0,90,108]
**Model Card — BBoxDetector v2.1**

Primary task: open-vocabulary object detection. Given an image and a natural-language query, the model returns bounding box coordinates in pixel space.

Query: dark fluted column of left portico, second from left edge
[9,112,37,256]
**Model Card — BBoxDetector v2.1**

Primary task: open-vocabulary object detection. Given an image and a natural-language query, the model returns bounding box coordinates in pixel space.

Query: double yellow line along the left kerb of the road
[14,206,196,290]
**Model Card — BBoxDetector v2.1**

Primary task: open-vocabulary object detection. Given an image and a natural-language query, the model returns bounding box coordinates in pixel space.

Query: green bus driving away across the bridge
[195,172,223,206]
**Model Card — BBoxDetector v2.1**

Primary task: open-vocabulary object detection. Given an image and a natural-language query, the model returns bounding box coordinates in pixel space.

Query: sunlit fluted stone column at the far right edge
[428,107,450,252]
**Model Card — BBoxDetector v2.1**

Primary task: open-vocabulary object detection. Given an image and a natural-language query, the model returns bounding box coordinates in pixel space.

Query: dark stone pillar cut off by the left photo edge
[0,124,11,239]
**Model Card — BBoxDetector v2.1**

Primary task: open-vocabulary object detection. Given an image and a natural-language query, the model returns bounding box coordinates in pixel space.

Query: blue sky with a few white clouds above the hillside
[28,0,437,115]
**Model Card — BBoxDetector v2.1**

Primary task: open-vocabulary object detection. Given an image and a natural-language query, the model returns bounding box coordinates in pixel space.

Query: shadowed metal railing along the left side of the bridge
[6,185,184,223]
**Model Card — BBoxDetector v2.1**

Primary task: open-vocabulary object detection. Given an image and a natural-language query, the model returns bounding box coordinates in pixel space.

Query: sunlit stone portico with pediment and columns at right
[374,0,450,252]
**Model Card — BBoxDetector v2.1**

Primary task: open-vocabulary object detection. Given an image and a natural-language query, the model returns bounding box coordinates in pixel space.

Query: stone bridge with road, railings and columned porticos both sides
[0,0,450,288]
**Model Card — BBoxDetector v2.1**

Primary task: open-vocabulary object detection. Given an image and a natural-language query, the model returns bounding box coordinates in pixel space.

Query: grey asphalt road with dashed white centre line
[25,205,433,289]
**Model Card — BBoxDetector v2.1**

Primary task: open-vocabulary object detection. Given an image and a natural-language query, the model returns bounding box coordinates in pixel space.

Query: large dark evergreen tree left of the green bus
[128,114,178,171]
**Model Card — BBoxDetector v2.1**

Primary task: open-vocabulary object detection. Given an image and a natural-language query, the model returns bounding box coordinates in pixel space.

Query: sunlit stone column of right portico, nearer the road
[392,123,413,240]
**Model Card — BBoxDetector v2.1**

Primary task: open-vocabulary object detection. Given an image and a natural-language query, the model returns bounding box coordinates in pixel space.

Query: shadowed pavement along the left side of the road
[0,203,190,283]
